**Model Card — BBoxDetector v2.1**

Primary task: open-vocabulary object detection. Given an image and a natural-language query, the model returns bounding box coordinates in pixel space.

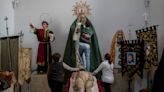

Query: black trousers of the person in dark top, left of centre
[48,79,63,92]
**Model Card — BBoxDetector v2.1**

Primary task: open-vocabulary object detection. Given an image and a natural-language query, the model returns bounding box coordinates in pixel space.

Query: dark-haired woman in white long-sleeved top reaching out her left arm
[92,53,114,92]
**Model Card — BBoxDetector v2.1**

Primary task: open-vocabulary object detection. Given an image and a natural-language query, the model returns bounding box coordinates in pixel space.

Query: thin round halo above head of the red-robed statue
[40,13,52,24]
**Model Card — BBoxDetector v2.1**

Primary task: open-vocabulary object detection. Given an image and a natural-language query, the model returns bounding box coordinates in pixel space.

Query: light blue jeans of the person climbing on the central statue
[79,42,90,71]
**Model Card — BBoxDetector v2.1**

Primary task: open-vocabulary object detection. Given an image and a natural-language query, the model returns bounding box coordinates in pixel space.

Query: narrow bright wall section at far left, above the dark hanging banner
[0,0,14,36]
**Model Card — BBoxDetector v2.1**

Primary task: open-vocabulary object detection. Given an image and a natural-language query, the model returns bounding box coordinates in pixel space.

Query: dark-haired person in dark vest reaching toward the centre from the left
[47,53,79,92]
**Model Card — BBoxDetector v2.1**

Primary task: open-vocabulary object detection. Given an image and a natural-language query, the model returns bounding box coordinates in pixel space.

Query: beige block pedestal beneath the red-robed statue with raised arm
[30,73,51,92]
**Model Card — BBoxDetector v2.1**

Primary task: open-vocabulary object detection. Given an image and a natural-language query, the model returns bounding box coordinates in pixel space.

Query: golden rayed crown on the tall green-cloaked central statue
[73,1,91,16]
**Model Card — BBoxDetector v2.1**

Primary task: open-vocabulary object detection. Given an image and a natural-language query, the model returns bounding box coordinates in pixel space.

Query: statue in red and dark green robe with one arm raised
[30,21,54,73]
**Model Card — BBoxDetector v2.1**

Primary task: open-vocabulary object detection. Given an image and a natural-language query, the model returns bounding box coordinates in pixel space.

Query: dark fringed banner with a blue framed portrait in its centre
[120,40,144,78]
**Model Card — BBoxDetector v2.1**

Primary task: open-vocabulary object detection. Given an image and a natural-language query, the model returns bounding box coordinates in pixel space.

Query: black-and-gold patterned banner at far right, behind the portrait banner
[136,25,158,68]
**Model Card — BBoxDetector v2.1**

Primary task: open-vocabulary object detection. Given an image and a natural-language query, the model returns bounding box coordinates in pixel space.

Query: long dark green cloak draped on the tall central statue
[63,18,102,79]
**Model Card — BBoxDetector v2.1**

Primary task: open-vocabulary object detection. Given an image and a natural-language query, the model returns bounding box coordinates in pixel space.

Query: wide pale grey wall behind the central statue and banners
[15,0,164,76]
